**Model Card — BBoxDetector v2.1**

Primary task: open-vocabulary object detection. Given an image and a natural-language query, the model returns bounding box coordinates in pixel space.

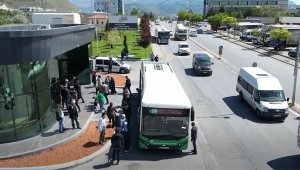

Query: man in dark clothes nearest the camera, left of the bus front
[111,128,124,164]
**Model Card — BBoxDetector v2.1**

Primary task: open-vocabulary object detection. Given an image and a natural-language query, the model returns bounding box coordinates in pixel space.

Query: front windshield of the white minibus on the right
[259,90,285,102]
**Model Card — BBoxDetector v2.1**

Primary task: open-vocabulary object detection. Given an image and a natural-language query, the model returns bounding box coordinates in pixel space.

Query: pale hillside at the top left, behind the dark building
[0,0,79,12]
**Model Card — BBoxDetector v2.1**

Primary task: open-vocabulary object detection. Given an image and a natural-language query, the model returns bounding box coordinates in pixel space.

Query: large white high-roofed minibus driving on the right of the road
[236,67,289,120]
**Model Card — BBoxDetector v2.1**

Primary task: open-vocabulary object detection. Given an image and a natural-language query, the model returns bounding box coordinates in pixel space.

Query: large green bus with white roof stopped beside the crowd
[138,62,194,150]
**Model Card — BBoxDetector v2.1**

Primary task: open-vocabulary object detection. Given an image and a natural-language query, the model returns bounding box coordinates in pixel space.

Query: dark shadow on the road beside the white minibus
[223,96,284,124]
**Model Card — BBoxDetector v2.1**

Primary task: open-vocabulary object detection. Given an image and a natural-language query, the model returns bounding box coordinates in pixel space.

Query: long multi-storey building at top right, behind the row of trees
[204,0,288,15]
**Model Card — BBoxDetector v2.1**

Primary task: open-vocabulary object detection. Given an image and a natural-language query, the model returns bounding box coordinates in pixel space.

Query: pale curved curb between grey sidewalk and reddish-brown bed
[0,112,95,160]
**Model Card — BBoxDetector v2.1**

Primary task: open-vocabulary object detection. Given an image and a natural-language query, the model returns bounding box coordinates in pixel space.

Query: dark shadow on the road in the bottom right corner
[267,155,300,170]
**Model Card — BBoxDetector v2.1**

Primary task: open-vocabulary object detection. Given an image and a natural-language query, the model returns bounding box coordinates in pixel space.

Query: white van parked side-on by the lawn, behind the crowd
[95,57,131,74]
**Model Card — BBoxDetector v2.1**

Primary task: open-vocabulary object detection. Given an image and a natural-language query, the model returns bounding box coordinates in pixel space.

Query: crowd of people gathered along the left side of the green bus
[93,72,131,163]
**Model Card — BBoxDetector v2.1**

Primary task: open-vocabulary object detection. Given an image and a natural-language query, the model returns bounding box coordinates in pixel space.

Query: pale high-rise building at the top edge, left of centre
[94,0,125,15]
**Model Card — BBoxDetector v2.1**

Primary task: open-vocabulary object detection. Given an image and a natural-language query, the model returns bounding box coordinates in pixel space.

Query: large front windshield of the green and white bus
[142,108,189,139]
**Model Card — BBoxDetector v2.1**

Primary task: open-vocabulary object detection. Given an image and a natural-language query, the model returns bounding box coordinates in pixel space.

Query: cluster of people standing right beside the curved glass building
[55,76,85,133]
